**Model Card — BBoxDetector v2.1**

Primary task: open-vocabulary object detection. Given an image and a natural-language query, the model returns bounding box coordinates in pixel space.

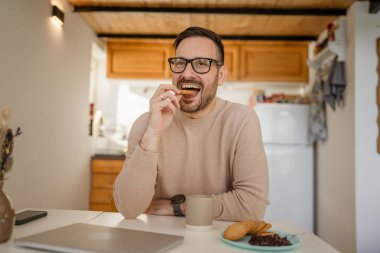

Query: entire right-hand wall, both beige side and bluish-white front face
[317,2,380,253]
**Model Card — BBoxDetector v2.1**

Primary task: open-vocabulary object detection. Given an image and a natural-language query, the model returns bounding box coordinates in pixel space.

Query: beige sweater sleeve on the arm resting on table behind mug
[214,111,269,221]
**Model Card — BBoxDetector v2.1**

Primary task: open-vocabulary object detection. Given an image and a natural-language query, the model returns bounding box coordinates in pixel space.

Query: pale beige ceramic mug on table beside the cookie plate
[185,195,223,231]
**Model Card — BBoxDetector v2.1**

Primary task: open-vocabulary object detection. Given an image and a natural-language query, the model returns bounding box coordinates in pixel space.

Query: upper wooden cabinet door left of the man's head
[107,42,172,78]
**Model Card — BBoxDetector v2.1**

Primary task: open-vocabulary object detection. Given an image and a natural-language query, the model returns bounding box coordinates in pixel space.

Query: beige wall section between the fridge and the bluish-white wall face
[316,14,355,253]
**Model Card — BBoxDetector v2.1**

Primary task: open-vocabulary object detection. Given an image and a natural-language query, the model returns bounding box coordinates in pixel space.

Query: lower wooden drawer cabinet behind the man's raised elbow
[90,157,125,211]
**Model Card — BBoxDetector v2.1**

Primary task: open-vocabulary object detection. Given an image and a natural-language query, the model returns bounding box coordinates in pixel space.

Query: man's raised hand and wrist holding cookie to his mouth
[140,84,181,152]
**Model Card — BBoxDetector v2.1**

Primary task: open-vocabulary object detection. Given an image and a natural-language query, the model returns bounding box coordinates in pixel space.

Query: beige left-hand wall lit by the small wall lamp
[0,0,95,210]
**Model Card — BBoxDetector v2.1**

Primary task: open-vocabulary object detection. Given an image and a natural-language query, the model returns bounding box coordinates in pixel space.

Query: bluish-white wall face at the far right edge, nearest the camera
[349,2,380,252]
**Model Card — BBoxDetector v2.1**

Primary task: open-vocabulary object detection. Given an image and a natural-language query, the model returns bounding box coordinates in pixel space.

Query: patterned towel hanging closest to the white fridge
[309,69,327,142]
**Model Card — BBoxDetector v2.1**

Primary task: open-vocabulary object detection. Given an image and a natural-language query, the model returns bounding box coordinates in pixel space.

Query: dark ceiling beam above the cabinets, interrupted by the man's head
[97,33,317,41]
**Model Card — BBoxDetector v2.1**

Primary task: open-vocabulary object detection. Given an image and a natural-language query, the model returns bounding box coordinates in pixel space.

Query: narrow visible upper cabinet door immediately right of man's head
[224,44,239,81]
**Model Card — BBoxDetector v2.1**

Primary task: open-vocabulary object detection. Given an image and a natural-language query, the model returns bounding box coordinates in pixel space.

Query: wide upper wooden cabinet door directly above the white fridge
[240,43,308,83]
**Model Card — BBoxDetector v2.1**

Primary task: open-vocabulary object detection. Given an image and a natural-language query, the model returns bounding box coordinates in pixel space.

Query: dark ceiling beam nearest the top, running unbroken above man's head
[74,6,346,16]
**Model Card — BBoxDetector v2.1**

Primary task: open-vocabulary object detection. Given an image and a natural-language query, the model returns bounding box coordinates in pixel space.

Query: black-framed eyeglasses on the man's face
[168,57,223,74]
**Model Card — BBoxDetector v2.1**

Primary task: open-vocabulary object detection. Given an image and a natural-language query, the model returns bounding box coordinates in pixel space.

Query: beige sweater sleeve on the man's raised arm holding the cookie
[113,114,158,218]
